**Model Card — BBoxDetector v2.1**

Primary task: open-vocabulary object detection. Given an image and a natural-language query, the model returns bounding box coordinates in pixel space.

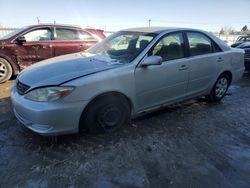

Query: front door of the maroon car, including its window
[15,28,53,69]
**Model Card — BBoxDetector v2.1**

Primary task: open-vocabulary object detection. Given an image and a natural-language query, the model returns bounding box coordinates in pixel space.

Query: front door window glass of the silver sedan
[150,33,184,61]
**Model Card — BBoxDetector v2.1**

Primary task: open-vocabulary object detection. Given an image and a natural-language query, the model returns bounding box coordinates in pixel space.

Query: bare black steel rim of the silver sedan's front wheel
[97,106,122,130]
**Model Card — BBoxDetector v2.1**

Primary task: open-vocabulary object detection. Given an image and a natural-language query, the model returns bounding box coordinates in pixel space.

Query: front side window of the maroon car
[24,29,52,42]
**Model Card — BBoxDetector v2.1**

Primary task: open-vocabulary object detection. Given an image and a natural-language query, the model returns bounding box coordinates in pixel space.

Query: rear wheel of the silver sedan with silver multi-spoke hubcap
[206,74,231,102]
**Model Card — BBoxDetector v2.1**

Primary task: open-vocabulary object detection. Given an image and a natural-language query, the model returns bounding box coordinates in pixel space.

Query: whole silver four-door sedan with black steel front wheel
[11,28,244,136]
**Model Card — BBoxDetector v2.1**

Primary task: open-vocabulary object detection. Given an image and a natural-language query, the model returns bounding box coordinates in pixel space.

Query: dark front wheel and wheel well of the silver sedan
[80,95,131,133]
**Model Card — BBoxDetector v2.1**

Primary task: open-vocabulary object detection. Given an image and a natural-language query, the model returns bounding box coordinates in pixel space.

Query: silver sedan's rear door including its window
[186,32,223,95]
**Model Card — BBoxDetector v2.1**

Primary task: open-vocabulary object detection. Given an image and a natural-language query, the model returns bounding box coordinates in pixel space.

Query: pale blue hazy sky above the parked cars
[0,0,250,31]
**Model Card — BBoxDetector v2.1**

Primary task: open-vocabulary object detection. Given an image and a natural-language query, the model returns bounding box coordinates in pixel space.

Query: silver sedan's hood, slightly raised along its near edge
[17,53,124,88]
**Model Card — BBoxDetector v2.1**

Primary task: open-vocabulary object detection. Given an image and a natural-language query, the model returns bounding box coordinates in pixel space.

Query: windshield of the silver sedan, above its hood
[87,31,156,63]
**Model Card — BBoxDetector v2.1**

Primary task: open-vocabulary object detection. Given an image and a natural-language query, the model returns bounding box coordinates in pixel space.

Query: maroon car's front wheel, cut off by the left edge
[0,58,13,83]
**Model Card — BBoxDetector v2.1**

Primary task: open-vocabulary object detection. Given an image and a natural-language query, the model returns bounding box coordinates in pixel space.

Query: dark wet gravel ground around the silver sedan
[0,74,250,188]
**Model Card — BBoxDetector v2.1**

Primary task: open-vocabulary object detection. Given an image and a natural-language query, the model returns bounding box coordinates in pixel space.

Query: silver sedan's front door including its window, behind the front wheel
[135,33,189,111]
